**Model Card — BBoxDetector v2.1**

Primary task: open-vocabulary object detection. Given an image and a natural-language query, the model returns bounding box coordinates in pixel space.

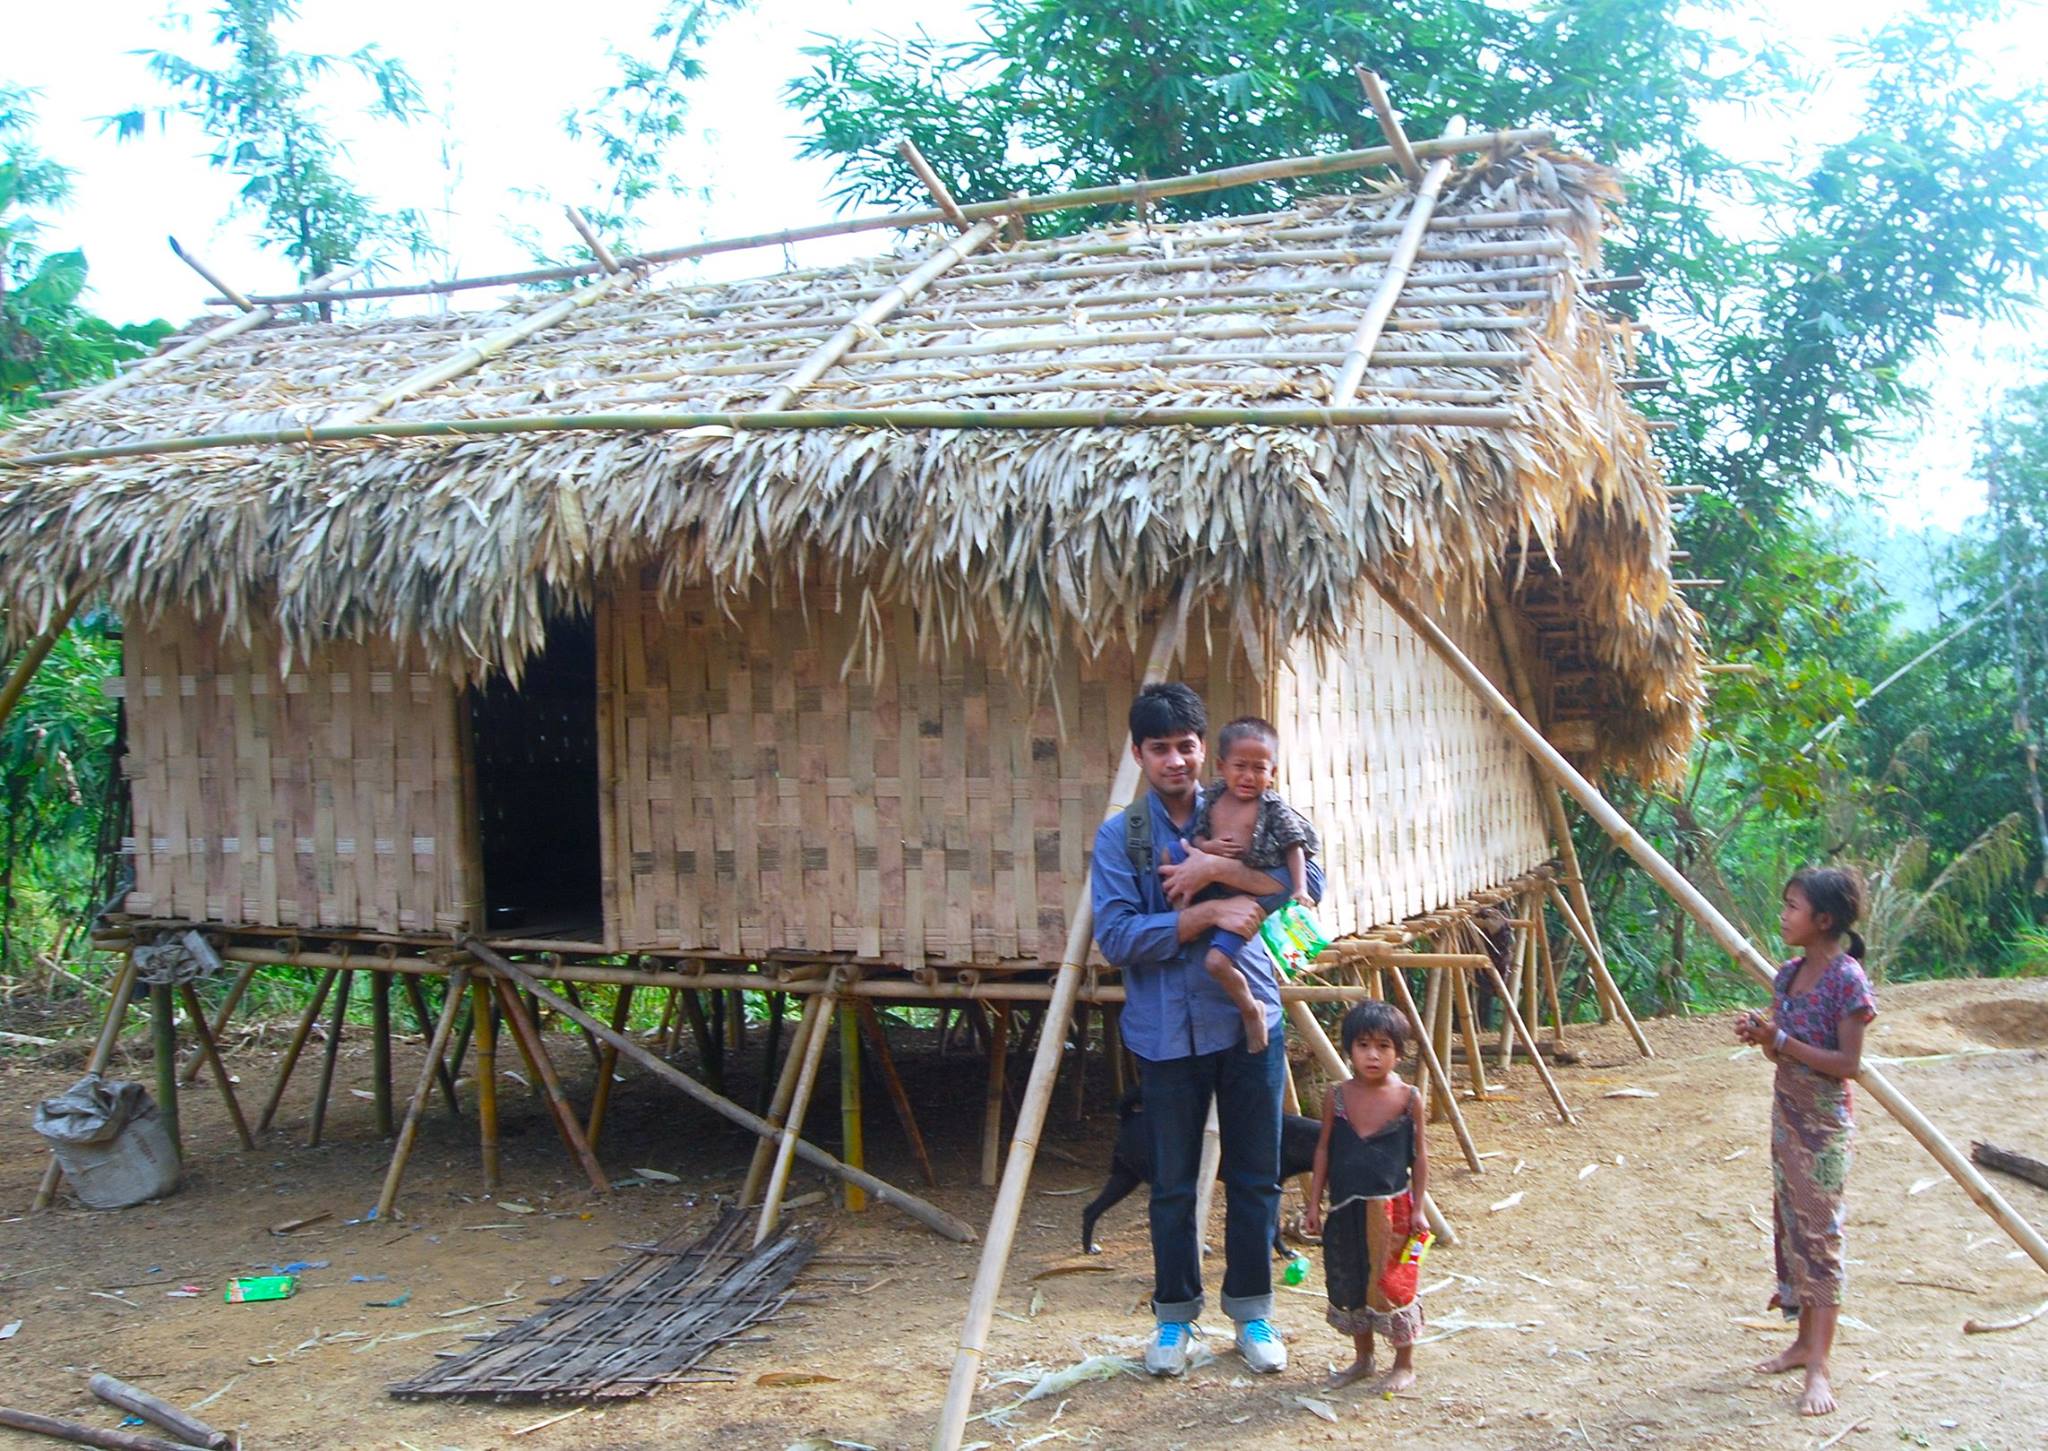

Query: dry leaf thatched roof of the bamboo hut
[0,152,1700,775]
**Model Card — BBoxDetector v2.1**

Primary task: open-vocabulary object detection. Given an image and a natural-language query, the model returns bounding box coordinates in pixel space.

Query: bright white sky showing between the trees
[0,0,2048,529]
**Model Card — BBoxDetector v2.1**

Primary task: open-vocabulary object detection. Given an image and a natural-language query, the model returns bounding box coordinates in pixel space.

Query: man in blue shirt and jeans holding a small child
[1092,682,1323,1375]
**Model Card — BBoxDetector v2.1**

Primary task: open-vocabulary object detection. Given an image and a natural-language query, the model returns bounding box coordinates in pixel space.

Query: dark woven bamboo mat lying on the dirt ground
[389,1209,817,1398]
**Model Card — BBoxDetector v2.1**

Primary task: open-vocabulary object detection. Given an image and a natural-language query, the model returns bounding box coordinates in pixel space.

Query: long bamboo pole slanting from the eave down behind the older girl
[1380,588,2048,1271]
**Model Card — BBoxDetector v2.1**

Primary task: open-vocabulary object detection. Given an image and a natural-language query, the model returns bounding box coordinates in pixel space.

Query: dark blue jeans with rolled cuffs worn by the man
[1139,1033,1286,1322]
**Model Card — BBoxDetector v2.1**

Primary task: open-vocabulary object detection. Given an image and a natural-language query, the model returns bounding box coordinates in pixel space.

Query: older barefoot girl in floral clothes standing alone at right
[1735,867,1878,1416]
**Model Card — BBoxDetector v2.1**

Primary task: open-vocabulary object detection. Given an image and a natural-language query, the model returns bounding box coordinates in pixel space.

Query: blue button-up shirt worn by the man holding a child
[1090,791,1323,1062]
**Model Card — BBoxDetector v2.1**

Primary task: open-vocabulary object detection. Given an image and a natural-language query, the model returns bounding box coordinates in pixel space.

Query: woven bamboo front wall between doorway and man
[598,580,1257,963]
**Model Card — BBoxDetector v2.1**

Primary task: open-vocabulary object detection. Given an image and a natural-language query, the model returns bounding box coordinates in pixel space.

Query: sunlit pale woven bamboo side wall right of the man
[1274,596,1550,932]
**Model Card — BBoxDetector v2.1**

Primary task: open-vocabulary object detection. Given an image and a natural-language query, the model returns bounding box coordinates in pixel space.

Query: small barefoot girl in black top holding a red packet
[1303,1000,1430,1392]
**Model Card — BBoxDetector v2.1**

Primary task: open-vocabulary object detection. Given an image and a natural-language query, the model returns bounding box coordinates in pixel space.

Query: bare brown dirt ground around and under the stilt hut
[0,982,2048,1451]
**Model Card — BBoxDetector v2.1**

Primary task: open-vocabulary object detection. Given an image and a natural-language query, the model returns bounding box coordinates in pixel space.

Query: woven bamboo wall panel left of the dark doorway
[109,621,471,932]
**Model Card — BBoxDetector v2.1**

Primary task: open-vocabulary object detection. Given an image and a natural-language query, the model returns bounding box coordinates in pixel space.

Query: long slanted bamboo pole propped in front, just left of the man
[932,586,1194,1451]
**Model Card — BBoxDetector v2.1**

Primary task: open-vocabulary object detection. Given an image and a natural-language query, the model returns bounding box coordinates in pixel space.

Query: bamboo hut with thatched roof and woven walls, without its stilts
[0,143,1700,967]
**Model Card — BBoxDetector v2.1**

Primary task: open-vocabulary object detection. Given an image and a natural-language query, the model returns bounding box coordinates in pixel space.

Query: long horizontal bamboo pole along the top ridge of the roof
[207,127,1554,303]
